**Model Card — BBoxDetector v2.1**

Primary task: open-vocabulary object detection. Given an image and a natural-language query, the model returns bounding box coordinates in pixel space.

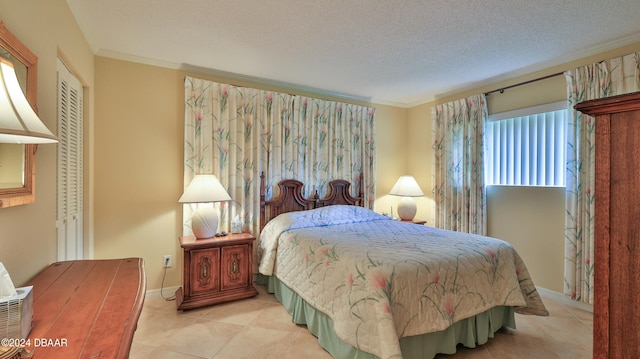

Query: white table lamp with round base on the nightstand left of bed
[178,175,231,238]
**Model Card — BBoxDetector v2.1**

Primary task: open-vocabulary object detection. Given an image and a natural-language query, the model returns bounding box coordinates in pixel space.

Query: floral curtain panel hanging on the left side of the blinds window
[433,94,488,235]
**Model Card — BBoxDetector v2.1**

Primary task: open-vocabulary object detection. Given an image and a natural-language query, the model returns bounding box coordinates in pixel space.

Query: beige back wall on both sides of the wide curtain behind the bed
[94,56,408,294]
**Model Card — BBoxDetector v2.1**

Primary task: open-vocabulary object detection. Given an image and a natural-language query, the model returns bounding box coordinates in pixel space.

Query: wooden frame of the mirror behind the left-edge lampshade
[0,20,38,208]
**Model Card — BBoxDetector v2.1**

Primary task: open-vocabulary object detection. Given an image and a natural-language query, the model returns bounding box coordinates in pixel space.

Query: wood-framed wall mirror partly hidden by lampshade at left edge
[0,20,38,208]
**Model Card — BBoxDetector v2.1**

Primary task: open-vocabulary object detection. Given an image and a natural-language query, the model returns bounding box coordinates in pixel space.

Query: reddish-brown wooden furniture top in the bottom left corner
[20,258,146,359]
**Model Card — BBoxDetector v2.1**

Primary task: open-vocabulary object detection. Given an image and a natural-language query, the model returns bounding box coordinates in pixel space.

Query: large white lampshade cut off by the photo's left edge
[0,58,58,144]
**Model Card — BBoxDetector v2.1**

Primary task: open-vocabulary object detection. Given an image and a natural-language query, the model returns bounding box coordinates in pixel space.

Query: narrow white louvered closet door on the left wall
[56,60,83,261]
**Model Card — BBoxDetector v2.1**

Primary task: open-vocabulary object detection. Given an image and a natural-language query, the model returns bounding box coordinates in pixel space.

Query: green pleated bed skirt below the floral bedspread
[257,274,516,359]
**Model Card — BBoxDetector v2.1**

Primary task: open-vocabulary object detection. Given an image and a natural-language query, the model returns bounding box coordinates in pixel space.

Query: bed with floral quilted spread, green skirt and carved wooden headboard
[258,176,548,359]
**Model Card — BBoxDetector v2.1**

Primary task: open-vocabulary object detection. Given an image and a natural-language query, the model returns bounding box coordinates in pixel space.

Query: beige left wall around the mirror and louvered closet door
[0,0,93,285]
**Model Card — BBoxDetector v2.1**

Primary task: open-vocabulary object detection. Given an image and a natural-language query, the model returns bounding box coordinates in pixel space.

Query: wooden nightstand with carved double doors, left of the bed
[176,233,258,310]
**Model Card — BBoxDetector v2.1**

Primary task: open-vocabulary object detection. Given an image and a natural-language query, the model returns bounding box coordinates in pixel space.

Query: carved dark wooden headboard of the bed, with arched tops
[260,173,364,230]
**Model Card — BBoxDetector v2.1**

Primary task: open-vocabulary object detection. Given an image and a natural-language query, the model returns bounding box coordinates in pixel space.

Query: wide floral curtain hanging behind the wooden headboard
[183,77,375,235]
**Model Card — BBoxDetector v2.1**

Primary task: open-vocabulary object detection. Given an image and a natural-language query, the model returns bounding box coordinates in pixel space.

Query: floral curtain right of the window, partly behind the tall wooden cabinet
[564,52,640,303]
